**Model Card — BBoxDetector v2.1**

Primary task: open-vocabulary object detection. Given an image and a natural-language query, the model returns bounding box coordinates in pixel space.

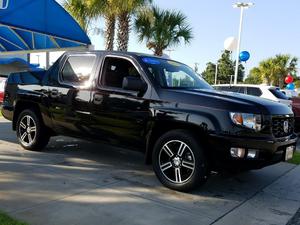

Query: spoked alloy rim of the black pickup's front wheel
[159,140,195,184]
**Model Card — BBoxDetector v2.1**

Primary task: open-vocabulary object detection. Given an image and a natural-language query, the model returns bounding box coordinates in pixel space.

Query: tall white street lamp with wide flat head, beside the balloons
[233,2,254,84]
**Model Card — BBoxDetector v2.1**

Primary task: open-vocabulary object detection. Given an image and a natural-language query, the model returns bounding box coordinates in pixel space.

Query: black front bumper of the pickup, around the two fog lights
[209,134,298,169]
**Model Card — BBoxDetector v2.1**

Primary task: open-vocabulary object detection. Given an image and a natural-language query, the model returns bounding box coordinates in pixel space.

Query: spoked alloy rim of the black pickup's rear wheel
[19,115,36,146]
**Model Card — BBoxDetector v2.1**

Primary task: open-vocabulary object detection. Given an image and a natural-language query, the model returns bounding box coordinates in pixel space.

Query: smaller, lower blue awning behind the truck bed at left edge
[0,58,41,76]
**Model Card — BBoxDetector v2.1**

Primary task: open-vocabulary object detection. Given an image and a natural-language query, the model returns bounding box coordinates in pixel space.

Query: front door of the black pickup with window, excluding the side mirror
[91,55,151,146]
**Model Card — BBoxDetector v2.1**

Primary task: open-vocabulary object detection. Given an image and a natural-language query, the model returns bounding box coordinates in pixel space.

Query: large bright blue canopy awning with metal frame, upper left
[0,0,91,55]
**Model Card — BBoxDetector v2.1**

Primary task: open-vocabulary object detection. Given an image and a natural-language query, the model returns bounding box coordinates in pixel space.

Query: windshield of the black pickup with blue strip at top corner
[142,57,213,89]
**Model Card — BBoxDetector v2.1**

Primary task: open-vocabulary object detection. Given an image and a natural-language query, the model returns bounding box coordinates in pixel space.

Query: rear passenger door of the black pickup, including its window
[48,54,97,136]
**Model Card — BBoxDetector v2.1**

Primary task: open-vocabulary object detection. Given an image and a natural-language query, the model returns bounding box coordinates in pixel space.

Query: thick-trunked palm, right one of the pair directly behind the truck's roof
[114,0,152,51]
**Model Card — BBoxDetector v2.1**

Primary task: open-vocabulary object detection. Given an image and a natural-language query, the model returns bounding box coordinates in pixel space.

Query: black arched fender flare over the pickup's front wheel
[145,121,207,164]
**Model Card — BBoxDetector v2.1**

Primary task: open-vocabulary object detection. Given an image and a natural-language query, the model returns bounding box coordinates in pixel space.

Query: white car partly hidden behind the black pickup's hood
[214,84,292,107]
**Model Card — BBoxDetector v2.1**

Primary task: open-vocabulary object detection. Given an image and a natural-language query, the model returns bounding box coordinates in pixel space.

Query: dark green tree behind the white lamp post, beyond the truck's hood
[202,51,245,84]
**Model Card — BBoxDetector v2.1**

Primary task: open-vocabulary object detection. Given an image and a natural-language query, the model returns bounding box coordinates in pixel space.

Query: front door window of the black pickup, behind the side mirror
[101,57,141,88]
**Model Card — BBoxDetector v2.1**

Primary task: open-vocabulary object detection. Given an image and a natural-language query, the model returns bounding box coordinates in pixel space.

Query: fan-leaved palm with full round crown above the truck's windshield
[135,6,193,56]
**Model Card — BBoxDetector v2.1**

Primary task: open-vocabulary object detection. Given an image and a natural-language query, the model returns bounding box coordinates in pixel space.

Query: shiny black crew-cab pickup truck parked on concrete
[2,51,297,191]
